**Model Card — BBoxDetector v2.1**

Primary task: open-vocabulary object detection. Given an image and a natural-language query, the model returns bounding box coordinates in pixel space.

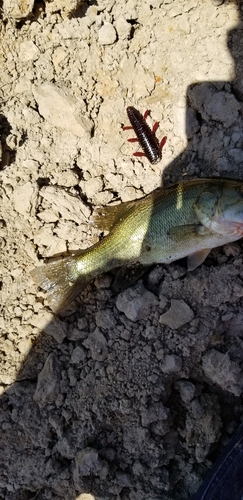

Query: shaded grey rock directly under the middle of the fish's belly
[116,283,158,321]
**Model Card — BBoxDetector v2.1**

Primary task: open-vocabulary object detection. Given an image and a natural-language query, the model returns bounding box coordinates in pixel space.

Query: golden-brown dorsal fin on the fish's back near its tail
[91,200,137,231]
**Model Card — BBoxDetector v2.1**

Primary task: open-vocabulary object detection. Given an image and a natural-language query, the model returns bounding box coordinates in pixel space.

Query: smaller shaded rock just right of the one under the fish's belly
[159,299,194,330]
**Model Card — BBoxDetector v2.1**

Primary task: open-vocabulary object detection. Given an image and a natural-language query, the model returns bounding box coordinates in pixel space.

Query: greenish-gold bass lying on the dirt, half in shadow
[31,178,243,312]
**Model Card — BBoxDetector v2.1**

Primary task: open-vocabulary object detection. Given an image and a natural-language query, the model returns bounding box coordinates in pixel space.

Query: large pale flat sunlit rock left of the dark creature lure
[33,83,93,138]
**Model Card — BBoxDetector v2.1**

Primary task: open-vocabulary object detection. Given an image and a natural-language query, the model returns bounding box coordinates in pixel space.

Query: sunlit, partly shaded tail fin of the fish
[31,256,90,313]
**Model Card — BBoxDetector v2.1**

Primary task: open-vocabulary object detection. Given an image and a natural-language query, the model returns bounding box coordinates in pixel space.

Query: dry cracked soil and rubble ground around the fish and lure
[0,0,243,500]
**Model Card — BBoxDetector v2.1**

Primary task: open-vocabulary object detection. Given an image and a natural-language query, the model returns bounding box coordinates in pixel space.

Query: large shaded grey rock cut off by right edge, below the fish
[202,349,243,396]
